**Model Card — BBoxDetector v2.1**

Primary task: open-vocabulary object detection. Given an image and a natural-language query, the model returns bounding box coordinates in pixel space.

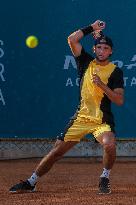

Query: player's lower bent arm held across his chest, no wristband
[93,74,124,106]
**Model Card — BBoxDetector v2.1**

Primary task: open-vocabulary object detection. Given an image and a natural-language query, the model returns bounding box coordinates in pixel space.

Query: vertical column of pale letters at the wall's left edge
[0,40,6,106]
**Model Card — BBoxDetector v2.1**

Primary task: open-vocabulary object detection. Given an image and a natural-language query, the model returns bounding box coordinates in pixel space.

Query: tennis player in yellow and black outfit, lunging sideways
[9,20,124,194]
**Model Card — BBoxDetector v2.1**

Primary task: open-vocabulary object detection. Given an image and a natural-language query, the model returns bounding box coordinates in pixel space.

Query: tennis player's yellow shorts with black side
[58,117,112,142]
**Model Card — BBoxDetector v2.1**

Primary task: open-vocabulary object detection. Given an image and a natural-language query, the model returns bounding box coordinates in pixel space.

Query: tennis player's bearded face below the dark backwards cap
[95,44,112,61]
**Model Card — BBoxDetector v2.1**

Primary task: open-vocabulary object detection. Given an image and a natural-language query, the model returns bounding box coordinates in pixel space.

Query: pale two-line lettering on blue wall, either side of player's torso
[63,54,136,87]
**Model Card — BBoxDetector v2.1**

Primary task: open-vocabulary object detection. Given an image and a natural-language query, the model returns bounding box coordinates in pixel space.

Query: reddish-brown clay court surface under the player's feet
[0,158,136,205]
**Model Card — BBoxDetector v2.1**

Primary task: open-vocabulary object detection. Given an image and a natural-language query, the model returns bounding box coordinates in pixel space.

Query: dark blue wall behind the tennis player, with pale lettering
[0,0,136,138]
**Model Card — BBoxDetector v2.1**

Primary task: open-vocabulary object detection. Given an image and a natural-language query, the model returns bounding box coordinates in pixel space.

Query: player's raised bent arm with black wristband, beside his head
[68,20,105,57]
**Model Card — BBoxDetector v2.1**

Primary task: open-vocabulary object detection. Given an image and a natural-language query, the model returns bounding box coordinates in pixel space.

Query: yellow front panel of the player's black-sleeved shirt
[79,59,116,123]
